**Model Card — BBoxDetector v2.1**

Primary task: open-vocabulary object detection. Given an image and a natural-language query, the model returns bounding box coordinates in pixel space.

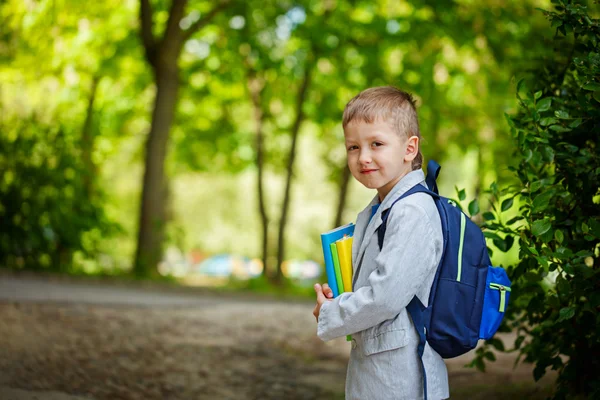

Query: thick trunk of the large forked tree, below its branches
[134,65,179,277]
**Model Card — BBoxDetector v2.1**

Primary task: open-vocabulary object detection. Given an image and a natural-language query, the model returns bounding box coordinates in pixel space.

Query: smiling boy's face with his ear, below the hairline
[344,121,418,200]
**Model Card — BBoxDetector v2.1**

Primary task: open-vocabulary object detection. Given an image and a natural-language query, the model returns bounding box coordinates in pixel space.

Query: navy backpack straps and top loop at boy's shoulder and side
[377,182,440,400]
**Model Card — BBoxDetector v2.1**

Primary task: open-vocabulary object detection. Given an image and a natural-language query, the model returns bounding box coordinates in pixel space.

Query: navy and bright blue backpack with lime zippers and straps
[377,160,510,398]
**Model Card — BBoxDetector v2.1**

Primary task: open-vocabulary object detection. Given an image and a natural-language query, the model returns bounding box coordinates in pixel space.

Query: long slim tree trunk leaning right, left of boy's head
[273,62,312,283]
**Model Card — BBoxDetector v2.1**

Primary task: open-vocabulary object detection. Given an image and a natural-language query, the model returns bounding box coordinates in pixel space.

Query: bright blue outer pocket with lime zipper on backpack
[479,266,510,340]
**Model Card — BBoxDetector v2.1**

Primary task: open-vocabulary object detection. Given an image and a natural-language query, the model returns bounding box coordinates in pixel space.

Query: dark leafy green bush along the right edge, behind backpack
[473,0,600,398]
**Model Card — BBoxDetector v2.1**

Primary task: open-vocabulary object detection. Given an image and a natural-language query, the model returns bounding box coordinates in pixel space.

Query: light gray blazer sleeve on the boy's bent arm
[317,202,442,340]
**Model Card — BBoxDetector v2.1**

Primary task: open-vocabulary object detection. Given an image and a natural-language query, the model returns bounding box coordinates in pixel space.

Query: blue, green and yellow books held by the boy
[321,223,354,340]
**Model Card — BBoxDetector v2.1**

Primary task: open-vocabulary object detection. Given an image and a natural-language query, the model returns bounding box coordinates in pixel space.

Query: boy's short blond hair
[342,86,423,171]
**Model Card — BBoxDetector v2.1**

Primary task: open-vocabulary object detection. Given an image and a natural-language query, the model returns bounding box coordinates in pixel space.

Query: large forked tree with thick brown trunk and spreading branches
[134,0,227,276]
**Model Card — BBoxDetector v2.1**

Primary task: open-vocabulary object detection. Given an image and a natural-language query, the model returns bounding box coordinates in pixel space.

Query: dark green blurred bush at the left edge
[0,118,118,271]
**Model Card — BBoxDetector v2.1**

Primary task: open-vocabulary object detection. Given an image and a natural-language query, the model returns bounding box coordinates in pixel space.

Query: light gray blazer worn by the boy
[317,170,449,400]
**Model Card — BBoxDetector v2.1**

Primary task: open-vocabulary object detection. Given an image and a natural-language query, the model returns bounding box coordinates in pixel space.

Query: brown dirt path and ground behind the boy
[0,276,552,400]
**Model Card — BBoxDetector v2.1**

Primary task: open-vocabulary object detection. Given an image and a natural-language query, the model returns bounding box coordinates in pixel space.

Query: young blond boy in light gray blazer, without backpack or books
[313,87,449,400]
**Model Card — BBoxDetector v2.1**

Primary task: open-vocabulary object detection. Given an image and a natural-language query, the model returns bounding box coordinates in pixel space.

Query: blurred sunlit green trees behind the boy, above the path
[0,0,552,285]
